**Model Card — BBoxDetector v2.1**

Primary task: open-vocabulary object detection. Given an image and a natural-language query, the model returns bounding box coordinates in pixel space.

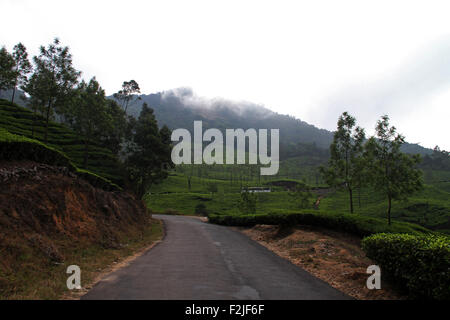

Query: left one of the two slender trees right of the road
[321,112,365,213]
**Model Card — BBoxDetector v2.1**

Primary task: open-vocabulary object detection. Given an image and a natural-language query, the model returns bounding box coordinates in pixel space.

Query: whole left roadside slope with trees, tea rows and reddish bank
[0,39,173,299]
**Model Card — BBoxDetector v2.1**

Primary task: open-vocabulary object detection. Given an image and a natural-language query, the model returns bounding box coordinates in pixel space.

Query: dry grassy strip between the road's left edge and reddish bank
[0,220,163,300]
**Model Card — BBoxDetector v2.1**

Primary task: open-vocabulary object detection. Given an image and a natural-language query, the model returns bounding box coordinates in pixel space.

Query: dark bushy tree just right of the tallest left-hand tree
[67,77,111,169]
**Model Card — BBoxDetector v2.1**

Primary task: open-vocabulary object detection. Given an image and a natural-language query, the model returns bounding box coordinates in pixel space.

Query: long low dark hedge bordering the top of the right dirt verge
[209,211,431,238]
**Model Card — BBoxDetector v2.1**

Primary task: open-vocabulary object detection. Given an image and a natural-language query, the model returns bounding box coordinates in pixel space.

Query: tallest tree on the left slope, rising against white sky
[24,38,81,142]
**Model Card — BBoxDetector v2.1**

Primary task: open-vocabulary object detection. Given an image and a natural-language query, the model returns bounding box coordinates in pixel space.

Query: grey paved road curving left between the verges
[82,215,348,300]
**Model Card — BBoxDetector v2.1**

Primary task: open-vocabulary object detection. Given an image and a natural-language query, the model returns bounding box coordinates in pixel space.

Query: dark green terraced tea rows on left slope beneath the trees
[0,100,123,185]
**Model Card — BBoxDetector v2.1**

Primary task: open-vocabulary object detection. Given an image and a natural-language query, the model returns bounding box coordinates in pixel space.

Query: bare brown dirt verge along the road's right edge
[235,225,406,300]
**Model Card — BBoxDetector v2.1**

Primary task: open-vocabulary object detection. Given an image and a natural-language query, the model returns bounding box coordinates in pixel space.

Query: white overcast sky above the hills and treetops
[0,0,450,150]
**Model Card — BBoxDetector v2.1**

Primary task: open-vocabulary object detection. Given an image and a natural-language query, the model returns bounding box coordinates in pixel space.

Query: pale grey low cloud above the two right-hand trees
[311,36,450,136]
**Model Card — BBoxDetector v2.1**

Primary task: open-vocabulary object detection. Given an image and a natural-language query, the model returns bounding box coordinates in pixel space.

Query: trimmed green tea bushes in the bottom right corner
[362,233,450,300]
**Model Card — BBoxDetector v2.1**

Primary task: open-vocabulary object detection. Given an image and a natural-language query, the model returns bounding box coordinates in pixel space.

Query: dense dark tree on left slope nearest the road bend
[127,103,174,197]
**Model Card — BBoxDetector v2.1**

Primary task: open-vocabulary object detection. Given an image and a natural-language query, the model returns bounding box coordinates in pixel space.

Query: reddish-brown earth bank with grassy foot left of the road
[0,161,162,299]
